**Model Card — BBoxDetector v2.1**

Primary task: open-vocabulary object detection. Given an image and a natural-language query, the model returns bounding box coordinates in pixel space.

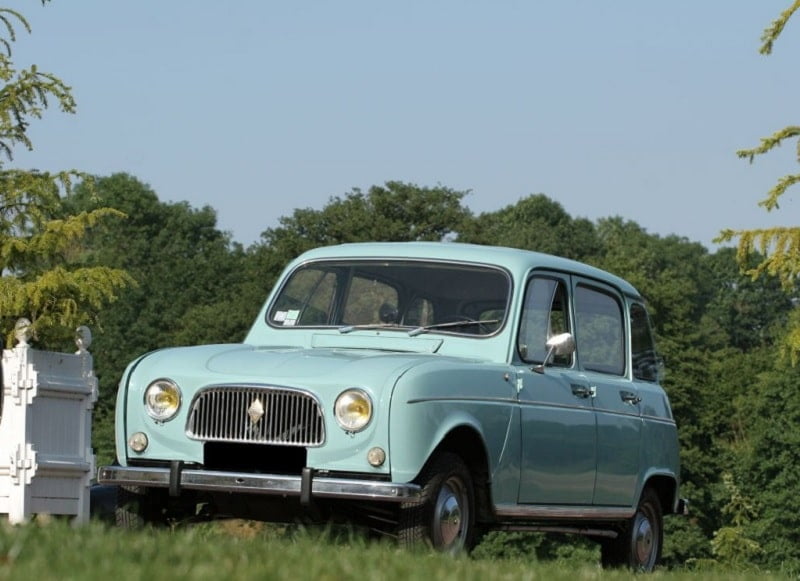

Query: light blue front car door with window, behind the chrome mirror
[517,271,597,505]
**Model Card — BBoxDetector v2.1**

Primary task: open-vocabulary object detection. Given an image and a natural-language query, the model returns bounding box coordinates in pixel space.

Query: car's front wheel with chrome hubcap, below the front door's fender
[398,452,475,554]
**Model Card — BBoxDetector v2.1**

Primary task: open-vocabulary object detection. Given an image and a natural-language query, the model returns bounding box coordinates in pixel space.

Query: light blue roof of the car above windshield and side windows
[295,242,641,298]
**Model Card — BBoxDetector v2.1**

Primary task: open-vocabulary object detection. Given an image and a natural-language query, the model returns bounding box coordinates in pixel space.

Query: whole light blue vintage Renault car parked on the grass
[98,242,685,571]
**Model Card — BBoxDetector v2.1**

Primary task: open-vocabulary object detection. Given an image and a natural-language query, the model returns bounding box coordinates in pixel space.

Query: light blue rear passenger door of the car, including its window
[573,277,642,506]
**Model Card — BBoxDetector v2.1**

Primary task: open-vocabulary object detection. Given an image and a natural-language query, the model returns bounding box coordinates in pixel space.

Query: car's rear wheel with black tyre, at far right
[600,488,664,573]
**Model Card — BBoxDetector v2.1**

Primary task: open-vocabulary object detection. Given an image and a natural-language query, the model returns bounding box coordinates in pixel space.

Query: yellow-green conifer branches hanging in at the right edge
[716,0,800,363]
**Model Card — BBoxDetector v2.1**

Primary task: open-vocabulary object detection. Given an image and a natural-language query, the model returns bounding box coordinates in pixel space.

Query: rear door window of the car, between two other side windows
[575,285,625,375]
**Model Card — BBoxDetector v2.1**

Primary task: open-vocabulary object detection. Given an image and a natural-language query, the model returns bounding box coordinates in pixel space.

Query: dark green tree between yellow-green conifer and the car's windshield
[64,173,247,461]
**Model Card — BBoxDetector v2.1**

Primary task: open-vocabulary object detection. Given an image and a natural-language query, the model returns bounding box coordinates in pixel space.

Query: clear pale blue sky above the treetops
[2,0,800,249]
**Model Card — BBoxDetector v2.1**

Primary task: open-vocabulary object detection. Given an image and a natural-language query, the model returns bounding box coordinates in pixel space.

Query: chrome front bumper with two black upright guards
[97,466,421,502]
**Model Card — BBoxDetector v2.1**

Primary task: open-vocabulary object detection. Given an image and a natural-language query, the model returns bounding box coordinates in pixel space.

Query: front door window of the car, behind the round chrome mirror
[517,276,572,366]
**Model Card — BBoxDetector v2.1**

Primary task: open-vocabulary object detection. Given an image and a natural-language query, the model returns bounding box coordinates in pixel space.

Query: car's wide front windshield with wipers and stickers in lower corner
[268,260,510,335]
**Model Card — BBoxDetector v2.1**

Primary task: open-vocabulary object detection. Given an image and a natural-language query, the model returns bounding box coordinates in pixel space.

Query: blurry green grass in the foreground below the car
[0,520,785,581]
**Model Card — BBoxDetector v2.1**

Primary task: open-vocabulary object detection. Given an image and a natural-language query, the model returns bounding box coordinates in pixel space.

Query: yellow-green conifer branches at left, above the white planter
[0,0,130,344]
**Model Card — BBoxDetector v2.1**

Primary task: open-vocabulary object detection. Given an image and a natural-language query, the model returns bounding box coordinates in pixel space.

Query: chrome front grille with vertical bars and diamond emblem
[186,386,325,446]
